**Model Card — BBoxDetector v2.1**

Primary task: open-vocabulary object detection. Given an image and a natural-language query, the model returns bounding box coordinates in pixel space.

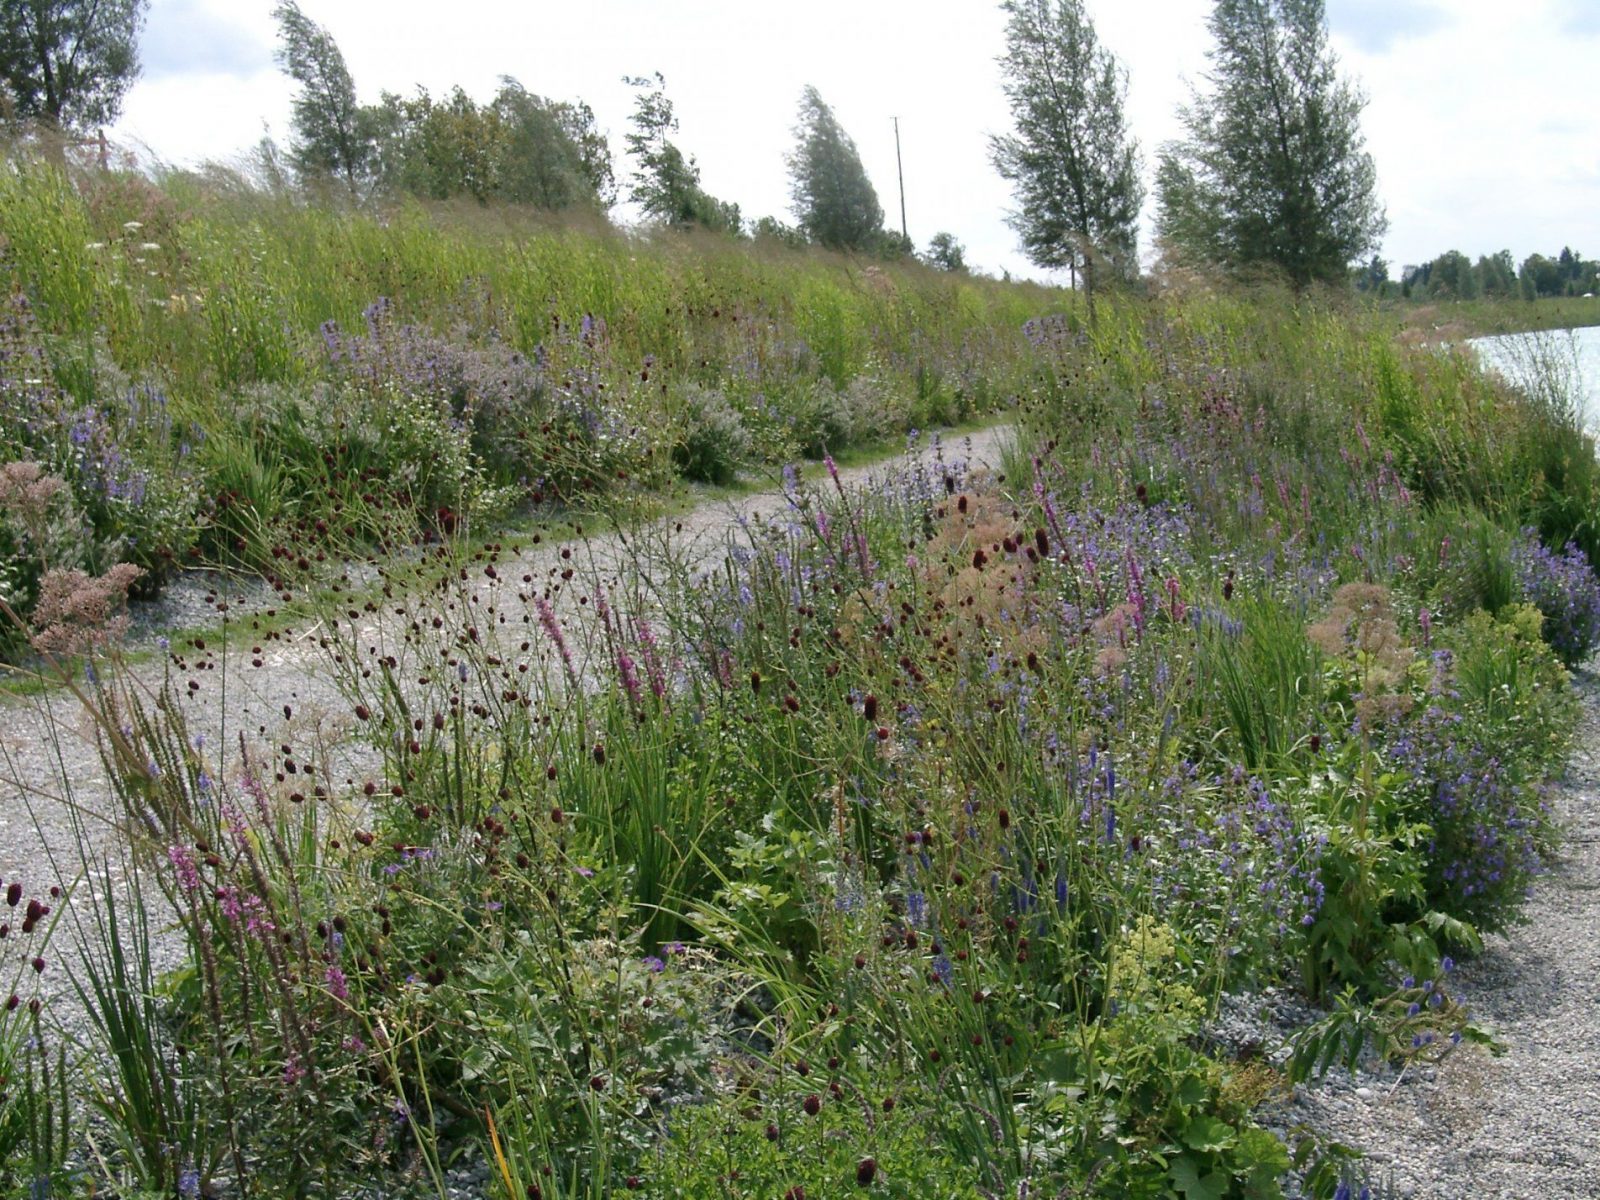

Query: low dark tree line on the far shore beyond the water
[1352,246,1600,301]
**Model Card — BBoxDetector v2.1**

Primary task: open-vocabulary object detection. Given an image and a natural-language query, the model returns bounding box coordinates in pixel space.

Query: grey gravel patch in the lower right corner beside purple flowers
[1291,662,1600,1200]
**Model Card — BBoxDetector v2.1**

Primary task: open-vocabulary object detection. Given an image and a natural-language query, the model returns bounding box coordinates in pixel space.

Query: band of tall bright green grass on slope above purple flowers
[0,166,1062,412]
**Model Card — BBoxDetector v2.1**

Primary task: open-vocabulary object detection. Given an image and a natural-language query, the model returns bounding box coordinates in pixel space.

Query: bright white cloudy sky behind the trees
[115,0,1600,283]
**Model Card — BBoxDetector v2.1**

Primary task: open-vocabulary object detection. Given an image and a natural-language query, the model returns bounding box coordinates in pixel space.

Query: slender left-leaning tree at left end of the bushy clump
[272,0,374,194]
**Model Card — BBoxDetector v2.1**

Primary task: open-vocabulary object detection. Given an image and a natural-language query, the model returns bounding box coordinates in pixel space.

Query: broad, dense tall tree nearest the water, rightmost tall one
[1157,0,1387,288]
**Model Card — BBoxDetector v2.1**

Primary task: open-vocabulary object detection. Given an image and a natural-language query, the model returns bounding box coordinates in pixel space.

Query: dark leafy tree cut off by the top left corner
[0,0,150,130]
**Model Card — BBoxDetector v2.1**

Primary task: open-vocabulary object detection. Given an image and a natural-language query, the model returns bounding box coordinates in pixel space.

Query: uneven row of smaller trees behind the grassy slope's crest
[274,0,934,270]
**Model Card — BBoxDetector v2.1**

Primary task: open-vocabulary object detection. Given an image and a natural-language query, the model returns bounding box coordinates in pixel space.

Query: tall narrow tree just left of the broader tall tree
[990,0,1144,302]
